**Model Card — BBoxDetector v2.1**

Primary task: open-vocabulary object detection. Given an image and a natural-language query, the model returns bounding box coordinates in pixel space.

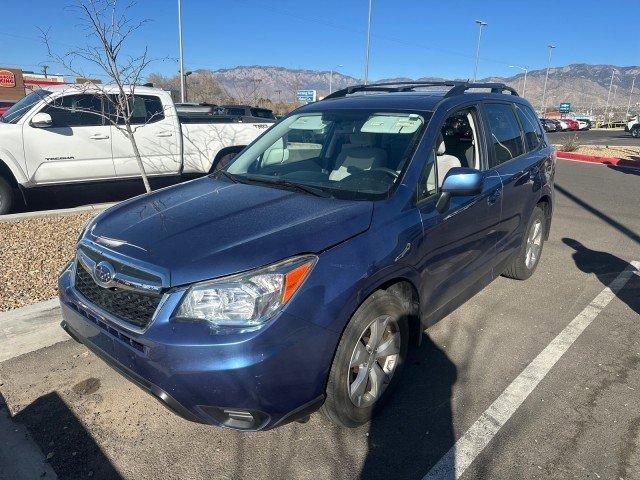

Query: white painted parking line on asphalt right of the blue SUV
[422,262,640,480]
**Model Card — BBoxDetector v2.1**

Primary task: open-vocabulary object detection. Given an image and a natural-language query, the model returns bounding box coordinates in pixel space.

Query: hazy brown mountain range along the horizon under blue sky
[213,63,640,113]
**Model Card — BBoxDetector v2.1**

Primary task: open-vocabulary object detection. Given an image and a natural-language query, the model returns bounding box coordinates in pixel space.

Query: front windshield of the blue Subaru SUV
[224,110,429,200]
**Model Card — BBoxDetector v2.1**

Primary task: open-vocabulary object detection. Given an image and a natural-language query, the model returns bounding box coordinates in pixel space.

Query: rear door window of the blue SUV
[485,103,524,167]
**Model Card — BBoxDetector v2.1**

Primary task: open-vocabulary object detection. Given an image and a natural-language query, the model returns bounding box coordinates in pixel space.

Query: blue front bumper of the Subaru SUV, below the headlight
[58,269,339,430]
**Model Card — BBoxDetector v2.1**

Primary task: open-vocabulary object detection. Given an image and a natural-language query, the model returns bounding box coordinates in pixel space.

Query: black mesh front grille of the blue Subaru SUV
[75,264,160,328]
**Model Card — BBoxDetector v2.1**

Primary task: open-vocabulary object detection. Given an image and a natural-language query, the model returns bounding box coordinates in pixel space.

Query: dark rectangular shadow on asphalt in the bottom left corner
[13,392,122,480]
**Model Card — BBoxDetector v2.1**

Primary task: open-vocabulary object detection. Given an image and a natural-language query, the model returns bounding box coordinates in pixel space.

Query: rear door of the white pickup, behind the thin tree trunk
[110,94,181,177]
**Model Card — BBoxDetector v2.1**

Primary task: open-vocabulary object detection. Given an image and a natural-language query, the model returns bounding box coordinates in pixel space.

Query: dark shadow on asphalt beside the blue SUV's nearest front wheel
[360,335,457,480]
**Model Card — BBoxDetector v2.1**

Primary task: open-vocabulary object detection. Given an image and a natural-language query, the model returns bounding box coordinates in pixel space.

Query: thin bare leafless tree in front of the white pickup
[42,0,156,192]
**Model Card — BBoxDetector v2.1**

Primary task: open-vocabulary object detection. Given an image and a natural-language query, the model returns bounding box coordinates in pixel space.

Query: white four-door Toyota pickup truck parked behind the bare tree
[0,85,273,215]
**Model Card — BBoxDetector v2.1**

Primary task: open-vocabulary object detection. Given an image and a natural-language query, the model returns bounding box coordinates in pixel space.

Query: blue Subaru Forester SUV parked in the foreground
[59,82,555,430]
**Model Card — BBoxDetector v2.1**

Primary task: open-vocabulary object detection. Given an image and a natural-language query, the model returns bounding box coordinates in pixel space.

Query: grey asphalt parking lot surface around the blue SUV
[0,160,640,480]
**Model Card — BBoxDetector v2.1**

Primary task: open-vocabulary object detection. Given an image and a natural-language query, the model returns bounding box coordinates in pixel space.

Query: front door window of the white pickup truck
[41,94,102,128]
